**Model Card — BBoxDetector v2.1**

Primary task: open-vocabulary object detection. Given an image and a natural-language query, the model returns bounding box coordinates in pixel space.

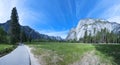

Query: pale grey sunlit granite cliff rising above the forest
[66,19,120,41]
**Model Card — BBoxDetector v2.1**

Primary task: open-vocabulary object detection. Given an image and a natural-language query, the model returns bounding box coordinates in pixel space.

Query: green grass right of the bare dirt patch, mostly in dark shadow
[95,44,120,65]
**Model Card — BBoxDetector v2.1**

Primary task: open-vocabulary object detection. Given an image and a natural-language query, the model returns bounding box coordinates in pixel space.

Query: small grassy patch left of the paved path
[0,44,15,57]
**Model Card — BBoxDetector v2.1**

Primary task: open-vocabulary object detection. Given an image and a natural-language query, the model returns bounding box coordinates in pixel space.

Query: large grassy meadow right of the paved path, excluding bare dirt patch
[29,42,120,65]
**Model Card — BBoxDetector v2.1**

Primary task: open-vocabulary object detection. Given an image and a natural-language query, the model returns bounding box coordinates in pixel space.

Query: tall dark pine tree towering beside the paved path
[10,7,20,44]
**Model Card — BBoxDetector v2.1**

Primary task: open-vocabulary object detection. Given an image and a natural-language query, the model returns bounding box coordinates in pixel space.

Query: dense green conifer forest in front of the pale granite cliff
[78,28,120,43]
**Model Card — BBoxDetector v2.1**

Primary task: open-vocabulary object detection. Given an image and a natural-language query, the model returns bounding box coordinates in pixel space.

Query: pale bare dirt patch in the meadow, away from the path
[70,51,100,65]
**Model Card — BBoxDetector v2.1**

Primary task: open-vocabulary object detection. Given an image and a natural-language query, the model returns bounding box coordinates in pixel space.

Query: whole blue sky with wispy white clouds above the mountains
[0,0,120,38]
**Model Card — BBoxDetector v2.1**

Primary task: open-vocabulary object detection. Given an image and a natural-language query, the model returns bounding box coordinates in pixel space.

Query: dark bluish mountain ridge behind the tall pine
[0,20,63,41]
